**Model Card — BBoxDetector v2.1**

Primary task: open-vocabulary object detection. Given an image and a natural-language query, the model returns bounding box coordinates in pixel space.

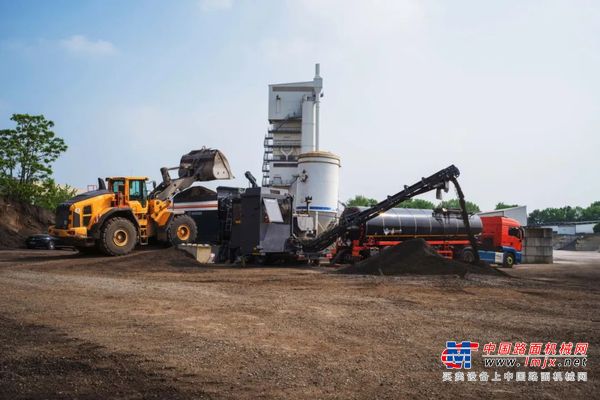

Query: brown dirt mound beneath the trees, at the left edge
[0,197,54,249]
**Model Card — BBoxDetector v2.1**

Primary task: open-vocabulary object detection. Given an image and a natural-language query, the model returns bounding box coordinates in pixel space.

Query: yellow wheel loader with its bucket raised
[49,148,233,256]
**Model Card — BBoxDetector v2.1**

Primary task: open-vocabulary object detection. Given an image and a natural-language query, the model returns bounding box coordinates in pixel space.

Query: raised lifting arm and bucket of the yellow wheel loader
[150,147,233,201]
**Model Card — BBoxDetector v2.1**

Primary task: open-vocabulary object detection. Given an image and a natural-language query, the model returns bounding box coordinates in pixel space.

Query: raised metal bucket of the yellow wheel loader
[178,148,233,181]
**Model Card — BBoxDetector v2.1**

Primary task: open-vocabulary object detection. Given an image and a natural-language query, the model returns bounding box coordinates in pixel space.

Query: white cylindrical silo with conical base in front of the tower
[294,151,340,233]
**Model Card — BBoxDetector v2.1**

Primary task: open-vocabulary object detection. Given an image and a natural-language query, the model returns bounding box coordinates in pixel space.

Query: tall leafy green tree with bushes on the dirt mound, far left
[0,114,72,207]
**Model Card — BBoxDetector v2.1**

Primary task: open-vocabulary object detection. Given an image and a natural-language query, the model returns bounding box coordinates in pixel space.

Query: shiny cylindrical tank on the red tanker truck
[344,207,482,239]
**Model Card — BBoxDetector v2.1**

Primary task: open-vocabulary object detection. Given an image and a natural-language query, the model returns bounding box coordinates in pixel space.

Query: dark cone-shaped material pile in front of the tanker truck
[336,239,504,277]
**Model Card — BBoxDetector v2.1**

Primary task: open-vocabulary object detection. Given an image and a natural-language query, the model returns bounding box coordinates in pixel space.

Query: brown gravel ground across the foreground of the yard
[0,249,600,399]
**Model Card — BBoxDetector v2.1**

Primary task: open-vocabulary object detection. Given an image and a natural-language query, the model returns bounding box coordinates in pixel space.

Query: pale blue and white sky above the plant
[0,0,600,211]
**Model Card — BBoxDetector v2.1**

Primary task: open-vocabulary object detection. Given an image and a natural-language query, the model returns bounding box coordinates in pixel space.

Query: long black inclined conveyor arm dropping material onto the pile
[301,165,460,252]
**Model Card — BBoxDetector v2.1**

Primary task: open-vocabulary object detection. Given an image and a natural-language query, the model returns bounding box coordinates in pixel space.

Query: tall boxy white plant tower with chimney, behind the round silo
[262,64,323,189]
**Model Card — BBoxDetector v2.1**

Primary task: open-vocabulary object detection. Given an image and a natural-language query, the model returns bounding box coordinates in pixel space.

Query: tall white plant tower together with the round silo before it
[262,64,340,234]
